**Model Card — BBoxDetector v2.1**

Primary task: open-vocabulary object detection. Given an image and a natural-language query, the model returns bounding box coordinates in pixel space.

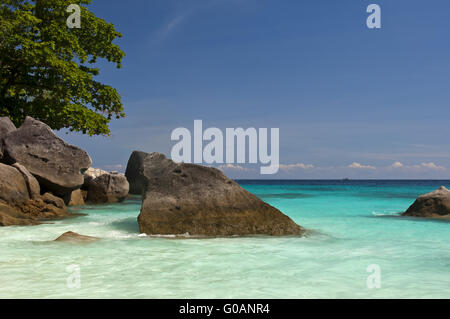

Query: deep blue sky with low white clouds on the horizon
[58,0,450,179]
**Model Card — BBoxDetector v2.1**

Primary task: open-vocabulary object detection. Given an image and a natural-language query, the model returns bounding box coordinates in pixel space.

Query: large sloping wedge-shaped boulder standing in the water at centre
[138,153,304,236]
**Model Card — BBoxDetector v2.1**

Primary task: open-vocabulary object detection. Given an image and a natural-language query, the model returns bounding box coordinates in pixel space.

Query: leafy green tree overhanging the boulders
[0,0,125,135]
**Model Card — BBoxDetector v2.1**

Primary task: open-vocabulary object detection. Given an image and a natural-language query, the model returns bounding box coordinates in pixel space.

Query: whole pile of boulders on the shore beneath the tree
[0,117,133,226]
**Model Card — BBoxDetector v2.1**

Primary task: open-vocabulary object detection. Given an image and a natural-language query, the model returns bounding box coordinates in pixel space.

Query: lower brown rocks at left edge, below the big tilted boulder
[0,163,71,226]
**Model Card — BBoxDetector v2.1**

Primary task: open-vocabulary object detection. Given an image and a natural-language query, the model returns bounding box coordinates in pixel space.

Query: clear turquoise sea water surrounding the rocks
[0,181,450,298]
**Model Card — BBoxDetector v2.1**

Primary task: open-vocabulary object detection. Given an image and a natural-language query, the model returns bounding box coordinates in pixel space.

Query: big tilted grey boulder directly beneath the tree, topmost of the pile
[4,117,92,195]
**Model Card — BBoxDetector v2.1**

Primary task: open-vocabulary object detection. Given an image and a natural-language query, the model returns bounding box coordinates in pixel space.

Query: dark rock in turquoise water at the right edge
[402,186,450,218]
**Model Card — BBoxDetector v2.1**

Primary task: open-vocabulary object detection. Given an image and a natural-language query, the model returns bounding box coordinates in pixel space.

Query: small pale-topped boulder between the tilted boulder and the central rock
[83,168,130,204]
